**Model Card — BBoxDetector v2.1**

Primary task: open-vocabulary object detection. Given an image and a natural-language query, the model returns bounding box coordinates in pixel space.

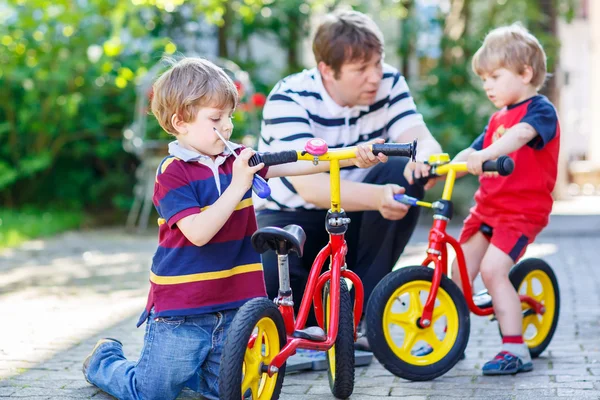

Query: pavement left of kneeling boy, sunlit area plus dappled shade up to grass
[0,232,156,379]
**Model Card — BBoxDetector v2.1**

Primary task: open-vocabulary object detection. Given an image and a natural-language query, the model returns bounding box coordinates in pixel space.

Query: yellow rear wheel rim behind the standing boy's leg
[518,270,556,348]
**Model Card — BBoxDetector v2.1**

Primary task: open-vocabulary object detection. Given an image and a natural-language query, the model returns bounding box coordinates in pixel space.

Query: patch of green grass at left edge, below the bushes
[0,208,84,249]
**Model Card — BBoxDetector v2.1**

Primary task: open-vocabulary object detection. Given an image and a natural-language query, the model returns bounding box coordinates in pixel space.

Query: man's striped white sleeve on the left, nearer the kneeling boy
[258,85,315,151]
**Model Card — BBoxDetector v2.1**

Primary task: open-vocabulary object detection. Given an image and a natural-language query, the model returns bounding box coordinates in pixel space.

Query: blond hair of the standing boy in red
[472,23,546,89]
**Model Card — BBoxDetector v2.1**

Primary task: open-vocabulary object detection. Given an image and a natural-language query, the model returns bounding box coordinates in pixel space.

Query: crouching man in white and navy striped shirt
[257,7,441,348]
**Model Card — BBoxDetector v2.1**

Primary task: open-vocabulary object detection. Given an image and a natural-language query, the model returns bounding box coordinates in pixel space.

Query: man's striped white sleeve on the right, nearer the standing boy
[386,71,425,141]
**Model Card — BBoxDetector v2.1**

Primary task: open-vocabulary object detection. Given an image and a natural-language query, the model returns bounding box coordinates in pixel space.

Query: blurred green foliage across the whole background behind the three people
[0,0,574,231]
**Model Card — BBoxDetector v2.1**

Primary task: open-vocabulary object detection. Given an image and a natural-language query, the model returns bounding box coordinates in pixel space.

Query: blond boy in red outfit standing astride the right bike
[452,24,560,375]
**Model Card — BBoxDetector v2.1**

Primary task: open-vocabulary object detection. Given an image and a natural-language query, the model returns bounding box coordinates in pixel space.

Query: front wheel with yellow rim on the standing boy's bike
[367,266,470,381]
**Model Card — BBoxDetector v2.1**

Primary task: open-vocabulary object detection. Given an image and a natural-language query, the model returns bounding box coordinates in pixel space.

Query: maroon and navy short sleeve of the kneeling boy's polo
[153,158,201,228]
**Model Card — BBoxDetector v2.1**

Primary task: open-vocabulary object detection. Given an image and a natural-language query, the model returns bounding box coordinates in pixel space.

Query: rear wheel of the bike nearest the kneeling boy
[219,298,286,400]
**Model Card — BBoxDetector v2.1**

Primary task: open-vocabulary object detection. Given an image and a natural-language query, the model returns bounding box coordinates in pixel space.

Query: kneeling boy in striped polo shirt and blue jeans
[83,58,387,400]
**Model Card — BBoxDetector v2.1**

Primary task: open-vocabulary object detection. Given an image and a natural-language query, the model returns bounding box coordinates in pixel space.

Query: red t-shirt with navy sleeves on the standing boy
[471,95,560,231]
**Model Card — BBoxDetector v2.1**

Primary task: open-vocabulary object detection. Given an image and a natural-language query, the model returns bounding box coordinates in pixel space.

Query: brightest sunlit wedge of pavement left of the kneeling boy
[0,289,146,378]
